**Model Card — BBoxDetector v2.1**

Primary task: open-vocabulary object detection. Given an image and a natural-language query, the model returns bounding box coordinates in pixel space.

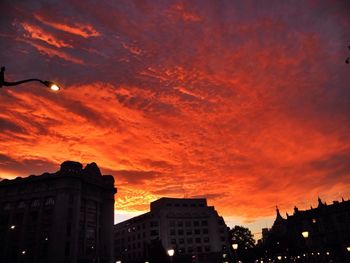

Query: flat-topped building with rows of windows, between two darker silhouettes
[114,198,231,263]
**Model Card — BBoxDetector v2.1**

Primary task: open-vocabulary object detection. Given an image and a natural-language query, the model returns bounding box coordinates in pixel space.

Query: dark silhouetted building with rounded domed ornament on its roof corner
[0,161,116,263]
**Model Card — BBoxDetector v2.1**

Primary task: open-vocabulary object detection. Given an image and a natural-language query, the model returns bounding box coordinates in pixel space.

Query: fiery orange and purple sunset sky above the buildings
[0,0,350,238]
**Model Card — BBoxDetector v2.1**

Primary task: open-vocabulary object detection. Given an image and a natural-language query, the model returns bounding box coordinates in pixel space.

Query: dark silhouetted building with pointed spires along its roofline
[261,198,350,262]
